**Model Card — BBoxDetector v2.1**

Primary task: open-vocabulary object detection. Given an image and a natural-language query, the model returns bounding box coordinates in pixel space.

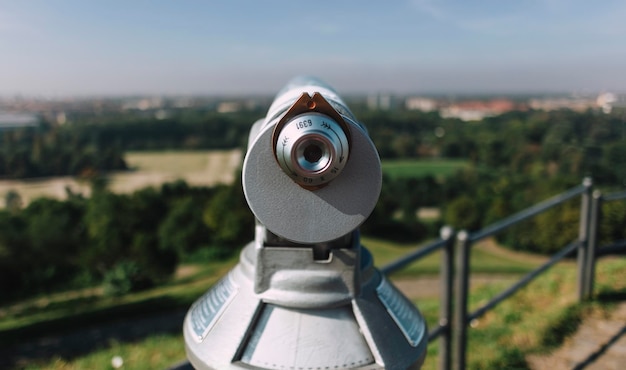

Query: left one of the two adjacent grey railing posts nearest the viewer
[439,226,454,370]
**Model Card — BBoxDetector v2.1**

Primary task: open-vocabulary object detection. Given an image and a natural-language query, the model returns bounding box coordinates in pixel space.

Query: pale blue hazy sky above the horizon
[0,0,626,96]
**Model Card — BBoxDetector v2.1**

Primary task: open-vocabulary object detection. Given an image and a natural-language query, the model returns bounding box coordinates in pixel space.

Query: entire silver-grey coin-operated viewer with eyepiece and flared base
[183,77,427,370]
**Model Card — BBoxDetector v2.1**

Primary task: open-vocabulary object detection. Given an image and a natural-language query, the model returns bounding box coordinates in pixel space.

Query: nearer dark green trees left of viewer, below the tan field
[0,181,254,301]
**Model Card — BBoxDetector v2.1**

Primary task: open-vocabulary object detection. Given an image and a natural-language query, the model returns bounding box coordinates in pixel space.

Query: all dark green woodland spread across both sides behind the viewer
[0,103,626,299]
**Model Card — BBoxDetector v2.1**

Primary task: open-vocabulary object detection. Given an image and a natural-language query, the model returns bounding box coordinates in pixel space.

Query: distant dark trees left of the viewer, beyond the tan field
[0,110,262,179]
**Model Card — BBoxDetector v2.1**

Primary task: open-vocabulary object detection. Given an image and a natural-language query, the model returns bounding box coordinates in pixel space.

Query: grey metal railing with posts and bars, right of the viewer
[380,178,626,370]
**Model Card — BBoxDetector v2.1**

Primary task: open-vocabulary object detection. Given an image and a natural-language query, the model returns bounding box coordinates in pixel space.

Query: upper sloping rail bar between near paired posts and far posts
[469,185,587,243]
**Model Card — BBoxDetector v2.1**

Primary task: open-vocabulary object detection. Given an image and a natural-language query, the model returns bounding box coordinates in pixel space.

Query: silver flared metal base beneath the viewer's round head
[183,243,428,370]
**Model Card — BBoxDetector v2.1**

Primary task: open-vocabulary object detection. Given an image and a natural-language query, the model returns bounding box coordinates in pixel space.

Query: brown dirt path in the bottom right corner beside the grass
[526,302,626,370]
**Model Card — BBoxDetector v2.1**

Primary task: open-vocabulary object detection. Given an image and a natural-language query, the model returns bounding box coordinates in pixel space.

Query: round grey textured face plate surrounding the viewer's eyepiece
[242,77,382,244]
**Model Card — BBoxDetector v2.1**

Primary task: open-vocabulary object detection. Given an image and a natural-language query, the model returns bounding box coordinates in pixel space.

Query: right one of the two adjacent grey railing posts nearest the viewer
[452,231,471,370]
